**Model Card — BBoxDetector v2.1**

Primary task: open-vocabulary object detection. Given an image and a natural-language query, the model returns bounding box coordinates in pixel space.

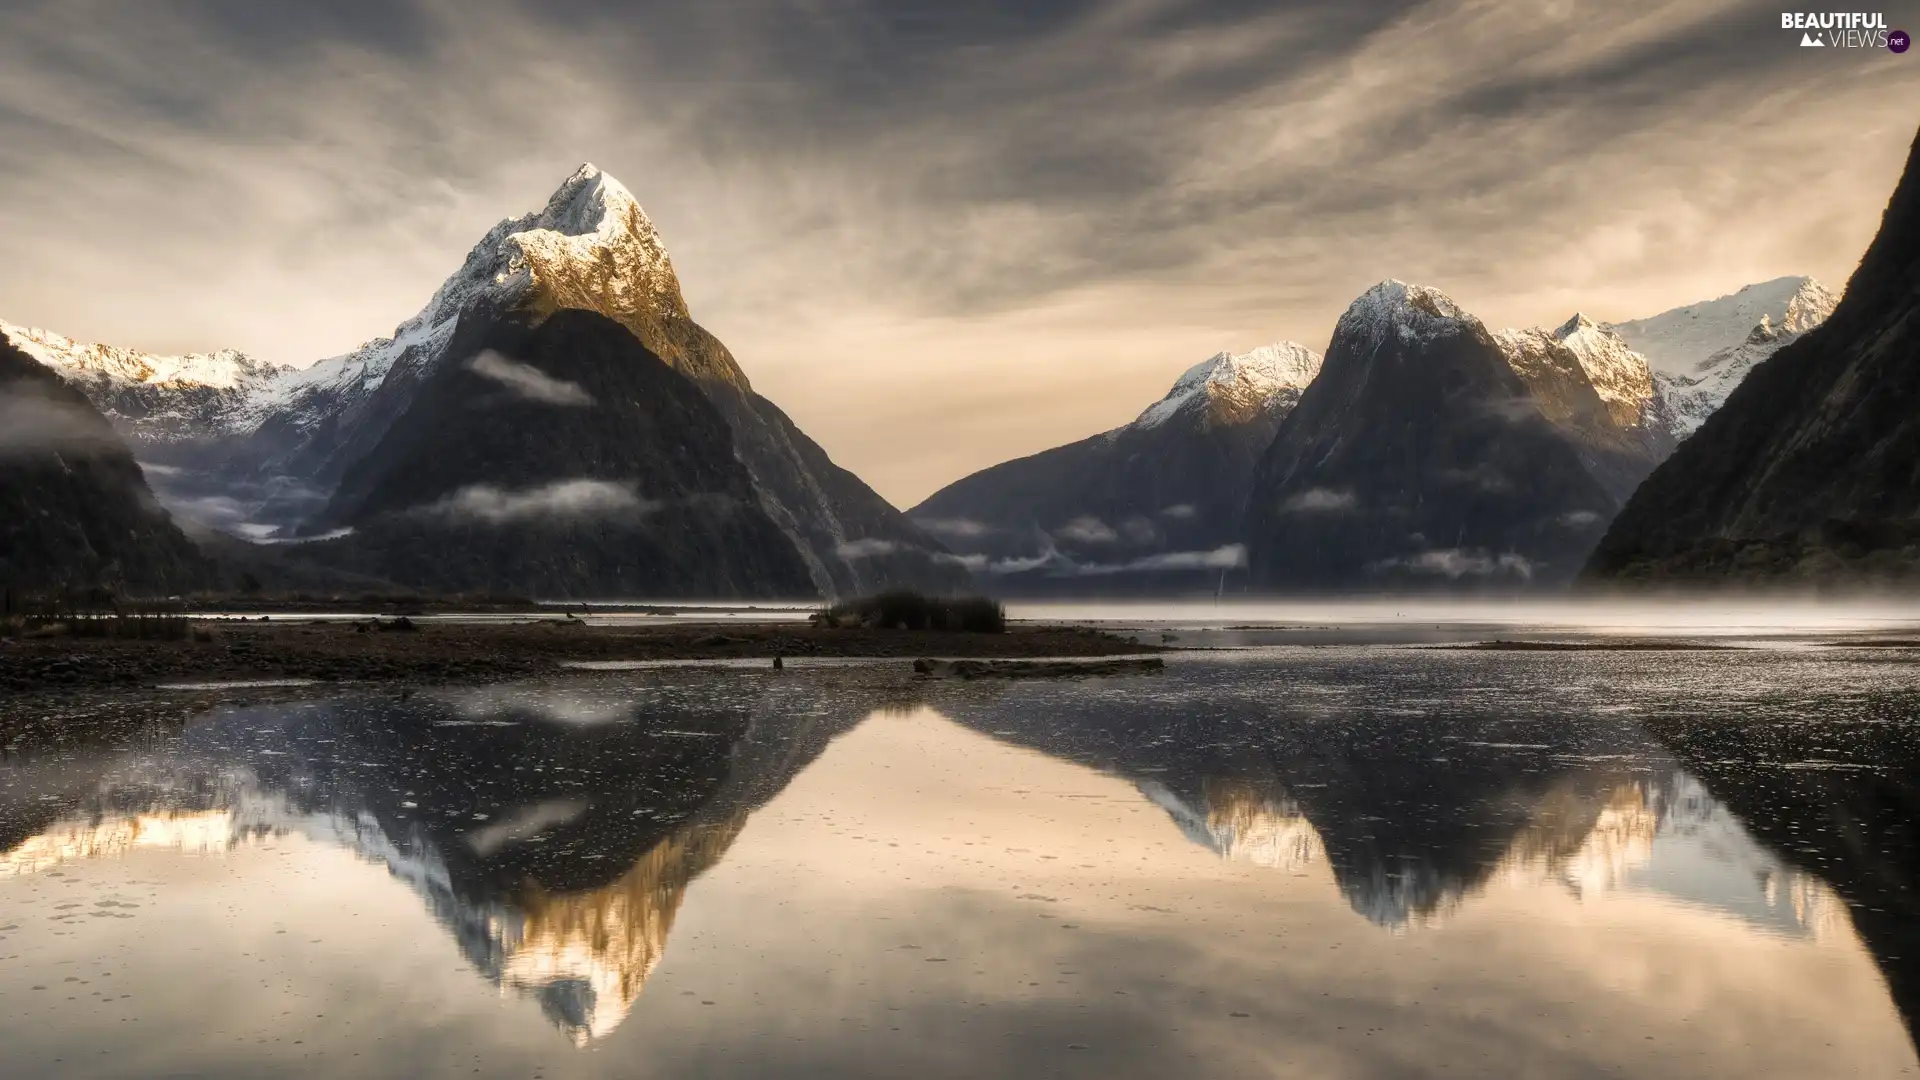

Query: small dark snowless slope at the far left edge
[0,340,209,594]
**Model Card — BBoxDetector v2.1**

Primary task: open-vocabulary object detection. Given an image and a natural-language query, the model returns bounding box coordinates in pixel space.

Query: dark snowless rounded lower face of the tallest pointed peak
[301,304,812,598]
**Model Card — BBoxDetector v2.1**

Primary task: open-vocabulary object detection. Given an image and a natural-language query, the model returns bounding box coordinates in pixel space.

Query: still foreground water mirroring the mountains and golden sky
[0,648,1920,1078]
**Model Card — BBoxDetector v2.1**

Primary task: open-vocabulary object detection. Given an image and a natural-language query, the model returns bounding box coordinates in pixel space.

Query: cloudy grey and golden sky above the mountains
[0,0,1920,507]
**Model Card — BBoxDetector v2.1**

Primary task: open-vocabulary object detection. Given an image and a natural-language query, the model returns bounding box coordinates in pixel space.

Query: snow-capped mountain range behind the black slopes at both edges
[0,155,1881,598]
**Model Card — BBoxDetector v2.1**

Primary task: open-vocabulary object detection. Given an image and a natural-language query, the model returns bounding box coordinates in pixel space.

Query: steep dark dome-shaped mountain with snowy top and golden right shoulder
[1246,281,1667,592]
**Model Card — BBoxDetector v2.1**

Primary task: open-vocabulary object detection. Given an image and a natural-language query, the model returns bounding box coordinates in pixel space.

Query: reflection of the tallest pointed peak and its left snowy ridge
[0,676,866,1045]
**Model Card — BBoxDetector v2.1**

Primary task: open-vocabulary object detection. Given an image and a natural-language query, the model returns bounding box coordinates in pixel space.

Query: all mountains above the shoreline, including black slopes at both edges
[0,127,1920,600]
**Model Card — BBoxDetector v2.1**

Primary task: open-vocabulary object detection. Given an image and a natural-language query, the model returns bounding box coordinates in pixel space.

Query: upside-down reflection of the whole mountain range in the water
[0,651,1920,1072]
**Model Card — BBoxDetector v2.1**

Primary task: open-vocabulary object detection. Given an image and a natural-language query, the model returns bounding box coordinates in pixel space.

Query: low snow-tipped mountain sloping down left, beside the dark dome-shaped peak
[908,342,1319,592]
